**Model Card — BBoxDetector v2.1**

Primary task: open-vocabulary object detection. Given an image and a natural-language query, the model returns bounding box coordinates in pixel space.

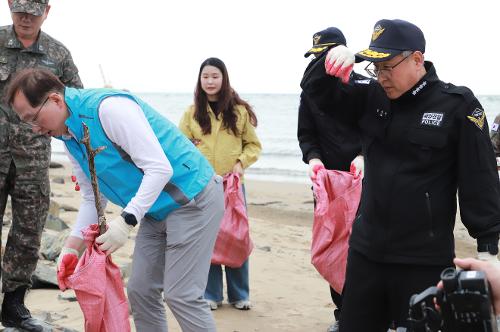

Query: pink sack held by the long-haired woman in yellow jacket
[212,173,253,268]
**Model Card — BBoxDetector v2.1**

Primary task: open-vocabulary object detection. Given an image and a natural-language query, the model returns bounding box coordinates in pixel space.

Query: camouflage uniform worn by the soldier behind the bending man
[0,24,82,292]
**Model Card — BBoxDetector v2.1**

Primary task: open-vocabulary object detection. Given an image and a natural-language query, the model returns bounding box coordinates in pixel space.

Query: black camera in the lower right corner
[397,268,498,332]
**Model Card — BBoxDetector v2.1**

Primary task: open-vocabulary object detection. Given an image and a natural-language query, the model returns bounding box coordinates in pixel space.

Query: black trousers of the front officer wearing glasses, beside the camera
[340,248,452,332]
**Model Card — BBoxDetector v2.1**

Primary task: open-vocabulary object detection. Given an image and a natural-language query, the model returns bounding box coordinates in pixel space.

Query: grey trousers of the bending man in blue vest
[127,175,224,332]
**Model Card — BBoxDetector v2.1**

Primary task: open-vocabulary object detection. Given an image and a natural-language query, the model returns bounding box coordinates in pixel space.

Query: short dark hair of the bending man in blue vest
[5,68,64,107]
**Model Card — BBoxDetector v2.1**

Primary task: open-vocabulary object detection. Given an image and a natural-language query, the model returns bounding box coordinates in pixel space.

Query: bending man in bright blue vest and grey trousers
[6,69,224,331]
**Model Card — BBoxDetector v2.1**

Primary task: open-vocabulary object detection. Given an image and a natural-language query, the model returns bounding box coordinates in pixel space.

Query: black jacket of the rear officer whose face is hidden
[297,52,362,171]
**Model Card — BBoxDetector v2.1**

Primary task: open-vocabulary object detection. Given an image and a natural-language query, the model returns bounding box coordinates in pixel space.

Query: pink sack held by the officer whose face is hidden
[311,168,361,294]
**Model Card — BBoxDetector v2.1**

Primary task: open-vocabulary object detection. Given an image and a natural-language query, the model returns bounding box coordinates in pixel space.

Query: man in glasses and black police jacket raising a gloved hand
[326,20,500,332]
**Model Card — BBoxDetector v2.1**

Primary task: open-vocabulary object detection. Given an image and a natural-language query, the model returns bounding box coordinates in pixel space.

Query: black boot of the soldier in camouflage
[2,287,46,332]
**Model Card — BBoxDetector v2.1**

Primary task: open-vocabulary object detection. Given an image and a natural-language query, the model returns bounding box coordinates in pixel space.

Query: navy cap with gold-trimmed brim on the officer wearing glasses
[356,19,425,62]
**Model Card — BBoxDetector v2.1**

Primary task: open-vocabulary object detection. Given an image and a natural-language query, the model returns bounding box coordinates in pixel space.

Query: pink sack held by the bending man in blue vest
[60,224,130,332]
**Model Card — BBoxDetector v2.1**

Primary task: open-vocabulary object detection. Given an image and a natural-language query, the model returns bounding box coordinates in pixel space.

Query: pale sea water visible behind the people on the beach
[52,93,500,183]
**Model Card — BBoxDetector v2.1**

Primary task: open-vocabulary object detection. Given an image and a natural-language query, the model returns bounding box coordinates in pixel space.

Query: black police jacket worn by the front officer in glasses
[348,62,500,265]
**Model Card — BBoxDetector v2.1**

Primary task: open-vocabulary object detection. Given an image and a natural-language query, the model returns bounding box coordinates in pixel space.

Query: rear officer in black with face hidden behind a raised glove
[297,27,365,332]
